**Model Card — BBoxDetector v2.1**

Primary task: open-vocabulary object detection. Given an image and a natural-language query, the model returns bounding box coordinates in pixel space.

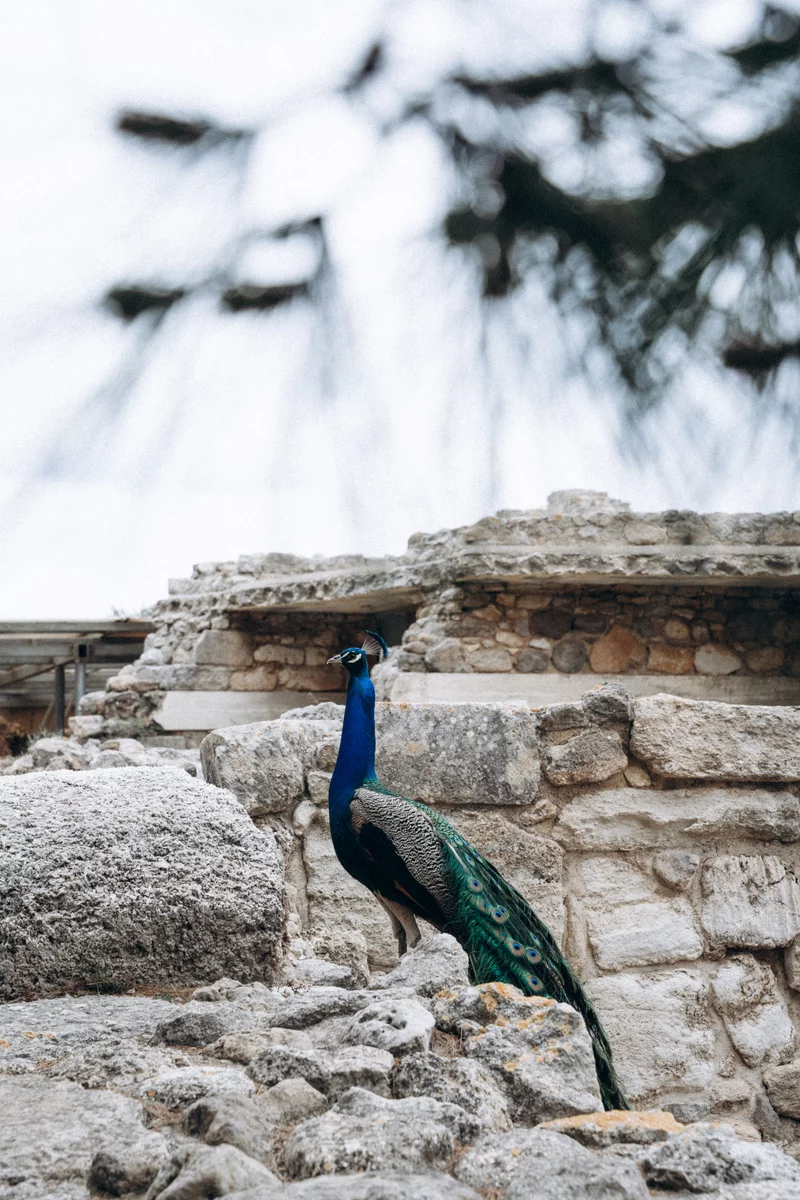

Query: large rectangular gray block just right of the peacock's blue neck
[375,700,539,805]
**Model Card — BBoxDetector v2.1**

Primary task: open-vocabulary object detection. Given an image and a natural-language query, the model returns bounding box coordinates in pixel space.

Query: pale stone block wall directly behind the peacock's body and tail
[201,691,800,1142]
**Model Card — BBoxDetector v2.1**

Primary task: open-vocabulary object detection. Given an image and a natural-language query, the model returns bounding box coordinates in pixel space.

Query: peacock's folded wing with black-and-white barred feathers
[350,787,456,929]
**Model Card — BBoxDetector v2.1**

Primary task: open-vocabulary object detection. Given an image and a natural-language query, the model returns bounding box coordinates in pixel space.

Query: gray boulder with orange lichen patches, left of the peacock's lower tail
[434,984,601,1124]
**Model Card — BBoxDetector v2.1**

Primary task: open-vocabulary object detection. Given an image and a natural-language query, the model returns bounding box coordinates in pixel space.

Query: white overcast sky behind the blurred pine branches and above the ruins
[0,0,800,619]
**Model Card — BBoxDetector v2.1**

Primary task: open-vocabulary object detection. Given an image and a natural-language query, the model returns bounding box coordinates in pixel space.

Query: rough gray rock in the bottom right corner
[639,1126,800,1192]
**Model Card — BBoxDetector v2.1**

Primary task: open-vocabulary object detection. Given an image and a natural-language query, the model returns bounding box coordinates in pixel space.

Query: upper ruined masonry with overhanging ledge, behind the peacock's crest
[64,492,800,745]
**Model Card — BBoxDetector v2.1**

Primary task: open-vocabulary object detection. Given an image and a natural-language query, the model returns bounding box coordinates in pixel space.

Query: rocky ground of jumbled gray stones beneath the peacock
[6,935,800,1200]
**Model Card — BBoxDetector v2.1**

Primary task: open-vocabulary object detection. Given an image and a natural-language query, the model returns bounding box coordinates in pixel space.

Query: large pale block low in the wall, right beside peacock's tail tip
[585,968,715,1100]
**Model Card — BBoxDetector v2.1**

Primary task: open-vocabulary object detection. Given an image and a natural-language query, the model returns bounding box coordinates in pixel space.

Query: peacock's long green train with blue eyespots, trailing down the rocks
[428,810,630,1109]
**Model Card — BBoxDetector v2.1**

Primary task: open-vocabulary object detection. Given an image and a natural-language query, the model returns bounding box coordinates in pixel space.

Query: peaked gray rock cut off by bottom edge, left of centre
[146,1146,278,1200]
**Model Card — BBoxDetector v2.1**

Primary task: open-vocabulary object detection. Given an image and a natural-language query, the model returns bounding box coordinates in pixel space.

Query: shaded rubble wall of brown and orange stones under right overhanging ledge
[397,583,800,678]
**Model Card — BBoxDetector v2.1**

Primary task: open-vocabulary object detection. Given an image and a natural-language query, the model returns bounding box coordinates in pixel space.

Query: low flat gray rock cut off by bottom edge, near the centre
[229,1171,482,1200]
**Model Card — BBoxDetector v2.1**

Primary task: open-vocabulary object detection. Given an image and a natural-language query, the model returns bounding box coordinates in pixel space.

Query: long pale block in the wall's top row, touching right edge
[631,691,800,782]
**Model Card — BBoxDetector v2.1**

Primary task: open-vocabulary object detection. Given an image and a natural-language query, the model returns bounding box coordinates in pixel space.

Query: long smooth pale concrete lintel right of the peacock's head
[391,672,800,708]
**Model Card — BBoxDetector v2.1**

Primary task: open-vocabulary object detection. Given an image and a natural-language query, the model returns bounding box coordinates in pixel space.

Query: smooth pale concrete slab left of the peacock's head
[154,691,344,732]
